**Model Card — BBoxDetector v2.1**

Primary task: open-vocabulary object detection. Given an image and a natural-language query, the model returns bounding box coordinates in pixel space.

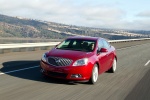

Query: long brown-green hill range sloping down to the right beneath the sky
[0,14,150,39]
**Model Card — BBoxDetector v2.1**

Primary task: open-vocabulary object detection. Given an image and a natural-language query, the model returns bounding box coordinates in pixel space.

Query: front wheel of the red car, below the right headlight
[89,64,98,84]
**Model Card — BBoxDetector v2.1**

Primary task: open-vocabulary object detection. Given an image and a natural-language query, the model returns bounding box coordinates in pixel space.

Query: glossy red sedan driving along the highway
[40,36,117,84]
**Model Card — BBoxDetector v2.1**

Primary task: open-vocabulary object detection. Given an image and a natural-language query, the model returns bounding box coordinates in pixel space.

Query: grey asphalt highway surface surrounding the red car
[0,41,150,100]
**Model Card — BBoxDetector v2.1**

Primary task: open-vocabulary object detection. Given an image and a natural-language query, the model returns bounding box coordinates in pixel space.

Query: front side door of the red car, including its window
[97,39,108,73]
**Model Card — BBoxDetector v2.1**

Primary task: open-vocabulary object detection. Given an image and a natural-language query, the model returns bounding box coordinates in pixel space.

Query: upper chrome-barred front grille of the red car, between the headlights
[48,57,72,66]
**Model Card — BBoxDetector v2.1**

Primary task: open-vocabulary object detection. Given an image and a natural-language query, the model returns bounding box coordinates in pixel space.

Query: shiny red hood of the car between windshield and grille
[47,48,92,60]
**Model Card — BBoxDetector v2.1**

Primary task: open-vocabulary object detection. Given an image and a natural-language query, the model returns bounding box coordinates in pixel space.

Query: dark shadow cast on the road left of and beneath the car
[0,61,88,85]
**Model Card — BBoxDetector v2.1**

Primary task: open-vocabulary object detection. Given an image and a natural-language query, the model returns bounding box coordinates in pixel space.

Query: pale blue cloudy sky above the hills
[0,0,150,30]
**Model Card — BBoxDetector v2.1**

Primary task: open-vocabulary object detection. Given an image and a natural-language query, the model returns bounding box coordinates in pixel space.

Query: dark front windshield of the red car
[57,39,96,52]
